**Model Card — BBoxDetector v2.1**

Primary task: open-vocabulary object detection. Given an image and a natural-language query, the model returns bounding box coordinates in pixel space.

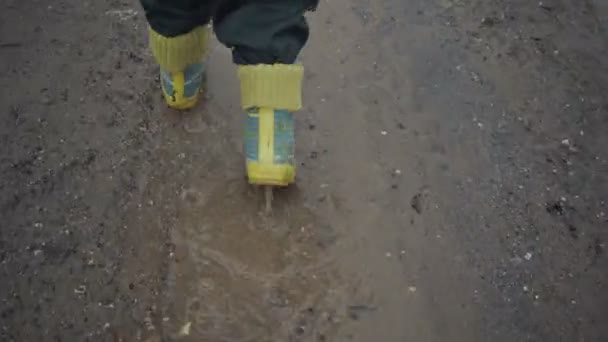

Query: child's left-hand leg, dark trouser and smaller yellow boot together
[141,0,212,109]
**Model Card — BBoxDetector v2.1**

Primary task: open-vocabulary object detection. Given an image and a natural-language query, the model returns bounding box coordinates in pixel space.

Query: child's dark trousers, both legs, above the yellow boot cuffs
[141,0,319,64]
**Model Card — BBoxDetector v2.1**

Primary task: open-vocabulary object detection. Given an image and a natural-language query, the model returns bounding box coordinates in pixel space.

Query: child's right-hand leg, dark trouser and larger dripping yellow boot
[214,0,317,185]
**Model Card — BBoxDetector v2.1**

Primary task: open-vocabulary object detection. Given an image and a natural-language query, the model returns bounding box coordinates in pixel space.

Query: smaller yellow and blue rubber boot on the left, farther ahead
[150,26,210,109]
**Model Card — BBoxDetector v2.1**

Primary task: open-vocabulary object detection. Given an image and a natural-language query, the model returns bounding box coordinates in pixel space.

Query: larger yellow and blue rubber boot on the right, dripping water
[239,64,304,186]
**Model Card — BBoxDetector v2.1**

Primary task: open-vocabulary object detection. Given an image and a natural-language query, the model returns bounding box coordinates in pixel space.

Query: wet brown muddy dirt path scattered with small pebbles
[0,0,608,342]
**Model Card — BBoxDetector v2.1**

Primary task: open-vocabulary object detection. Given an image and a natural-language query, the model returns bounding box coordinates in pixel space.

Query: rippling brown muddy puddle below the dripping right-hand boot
[164,182,338,341]
